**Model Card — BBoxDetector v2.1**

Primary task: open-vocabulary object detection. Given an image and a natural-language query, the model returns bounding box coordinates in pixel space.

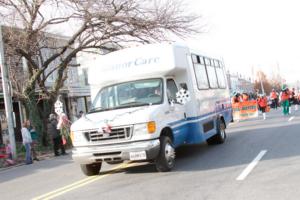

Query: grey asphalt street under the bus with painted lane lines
[0,110,300,200]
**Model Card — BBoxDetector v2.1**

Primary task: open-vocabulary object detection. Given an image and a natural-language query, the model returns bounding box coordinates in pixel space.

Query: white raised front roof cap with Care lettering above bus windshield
[88,43,189,85]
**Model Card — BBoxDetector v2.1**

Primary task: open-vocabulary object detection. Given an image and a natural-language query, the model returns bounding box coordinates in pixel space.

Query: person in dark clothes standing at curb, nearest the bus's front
[48,114,66,156]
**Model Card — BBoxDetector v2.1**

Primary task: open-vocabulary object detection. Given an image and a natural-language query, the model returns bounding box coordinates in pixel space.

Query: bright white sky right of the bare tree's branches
[183,0,300,82]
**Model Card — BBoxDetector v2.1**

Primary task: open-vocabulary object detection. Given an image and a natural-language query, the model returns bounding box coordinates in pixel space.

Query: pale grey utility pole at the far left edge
[0,26,17,159]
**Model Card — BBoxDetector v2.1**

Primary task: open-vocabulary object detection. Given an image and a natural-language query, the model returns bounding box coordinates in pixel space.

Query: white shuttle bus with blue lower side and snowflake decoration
[71,43,232,175]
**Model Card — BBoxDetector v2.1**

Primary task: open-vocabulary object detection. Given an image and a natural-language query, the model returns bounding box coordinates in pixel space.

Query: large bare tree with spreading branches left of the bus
[0,0,200,145]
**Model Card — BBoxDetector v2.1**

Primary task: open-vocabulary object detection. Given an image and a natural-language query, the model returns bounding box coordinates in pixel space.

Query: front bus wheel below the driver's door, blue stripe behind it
[155,135,175,172]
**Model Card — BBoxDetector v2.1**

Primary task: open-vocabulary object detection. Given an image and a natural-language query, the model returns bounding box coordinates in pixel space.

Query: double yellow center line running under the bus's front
[32,163,134,200]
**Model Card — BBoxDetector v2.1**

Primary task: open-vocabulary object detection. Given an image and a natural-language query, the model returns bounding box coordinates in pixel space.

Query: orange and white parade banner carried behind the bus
[232,100,258,120]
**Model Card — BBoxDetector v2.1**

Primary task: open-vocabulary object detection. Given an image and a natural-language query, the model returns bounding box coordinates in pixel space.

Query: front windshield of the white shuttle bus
[90,79,163,112]
